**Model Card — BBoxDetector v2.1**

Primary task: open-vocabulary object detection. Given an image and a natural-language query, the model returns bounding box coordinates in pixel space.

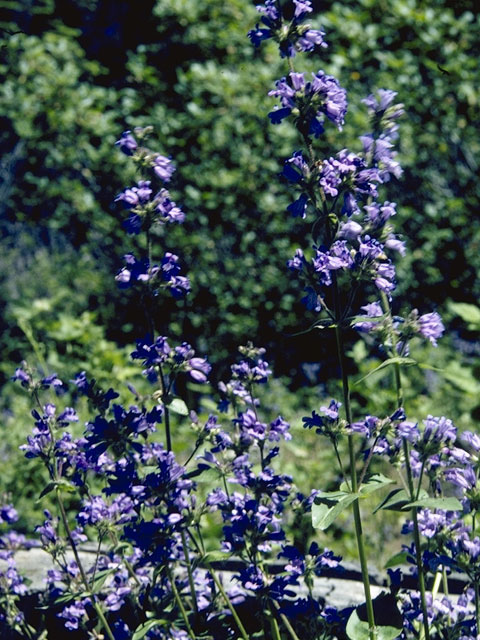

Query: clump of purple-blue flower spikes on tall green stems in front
[0,0,480,640]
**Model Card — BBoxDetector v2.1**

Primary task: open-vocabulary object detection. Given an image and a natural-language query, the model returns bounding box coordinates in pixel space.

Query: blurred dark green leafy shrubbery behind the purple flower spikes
[0,0,480,552]
